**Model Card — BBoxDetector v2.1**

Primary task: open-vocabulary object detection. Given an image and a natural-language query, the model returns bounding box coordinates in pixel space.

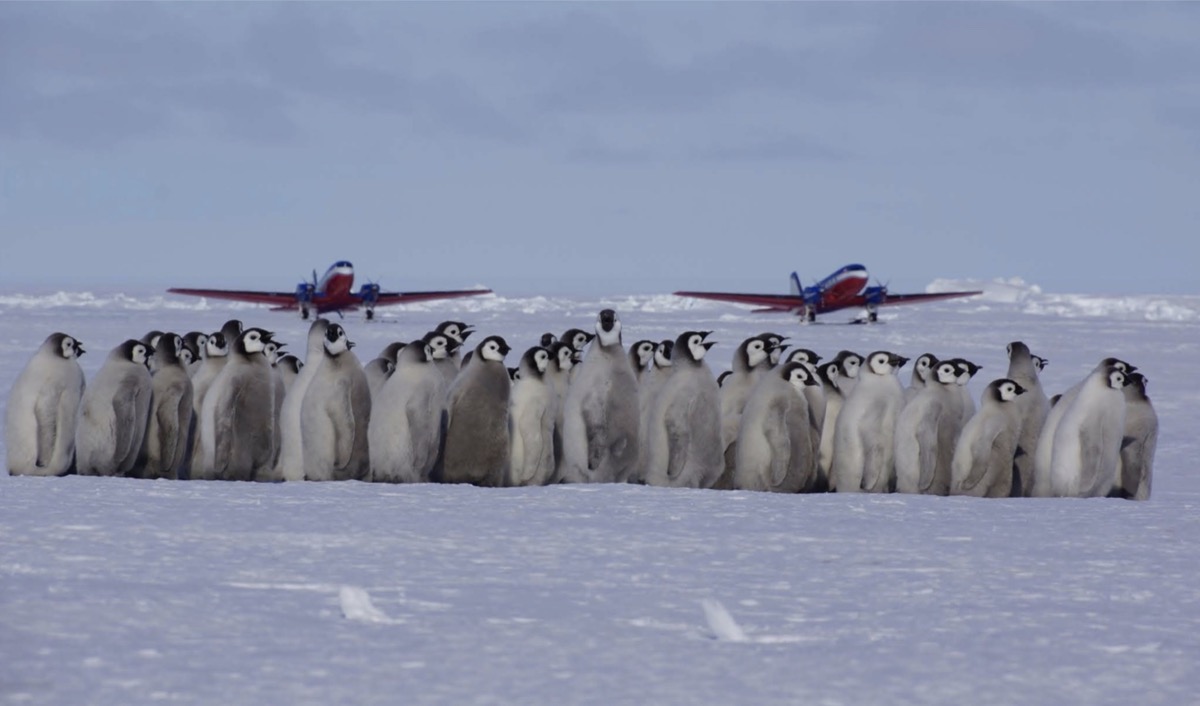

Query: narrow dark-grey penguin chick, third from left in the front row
[136,331,192,480]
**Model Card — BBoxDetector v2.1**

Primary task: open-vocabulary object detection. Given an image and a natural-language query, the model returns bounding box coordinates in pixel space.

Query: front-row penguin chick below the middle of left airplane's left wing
[206,327,277,480]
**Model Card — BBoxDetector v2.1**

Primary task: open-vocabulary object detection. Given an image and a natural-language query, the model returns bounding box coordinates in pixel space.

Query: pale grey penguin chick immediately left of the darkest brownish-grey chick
[367,331,450,483]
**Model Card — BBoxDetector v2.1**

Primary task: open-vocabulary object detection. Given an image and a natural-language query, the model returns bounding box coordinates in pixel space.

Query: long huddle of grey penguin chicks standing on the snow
[6,309,1158,499]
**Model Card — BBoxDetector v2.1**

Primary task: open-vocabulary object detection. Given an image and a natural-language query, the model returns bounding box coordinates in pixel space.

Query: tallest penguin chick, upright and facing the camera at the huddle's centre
[562,309,640,483]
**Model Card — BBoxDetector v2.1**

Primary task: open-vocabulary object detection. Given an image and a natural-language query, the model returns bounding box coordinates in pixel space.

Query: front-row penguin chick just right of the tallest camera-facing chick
[642,331,725,487]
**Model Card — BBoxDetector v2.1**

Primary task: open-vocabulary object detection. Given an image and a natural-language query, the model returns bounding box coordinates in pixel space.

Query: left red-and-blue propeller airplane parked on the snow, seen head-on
[167,259,492,321]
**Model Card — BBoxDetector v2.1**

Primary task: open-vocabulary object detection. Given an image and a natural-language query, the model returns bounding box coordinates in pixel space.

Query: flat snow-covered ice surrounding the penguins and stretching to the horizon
[0,280,1200,705]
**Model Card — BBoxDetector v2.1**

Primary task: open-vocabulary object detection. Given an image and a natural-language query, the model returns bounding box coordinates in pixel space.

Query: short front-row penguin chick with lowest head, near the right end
[950,377,1025,497]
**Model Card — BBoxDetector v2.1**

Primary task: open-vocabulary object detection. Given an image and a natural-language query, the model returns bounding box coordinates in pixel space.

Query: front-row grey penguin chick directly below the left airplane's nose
[300,323,371,480]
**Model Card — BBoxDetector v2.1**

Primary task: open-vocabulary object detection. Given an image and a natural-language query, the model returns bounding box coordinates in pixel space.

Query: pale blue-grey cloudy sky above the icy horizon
[0,2,1200,295]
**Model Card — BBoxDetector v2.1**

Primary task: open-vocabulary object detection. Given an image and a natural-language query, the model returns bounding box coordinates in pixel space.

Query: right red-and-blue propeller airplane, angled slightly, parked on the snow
[674,264,983,323]
